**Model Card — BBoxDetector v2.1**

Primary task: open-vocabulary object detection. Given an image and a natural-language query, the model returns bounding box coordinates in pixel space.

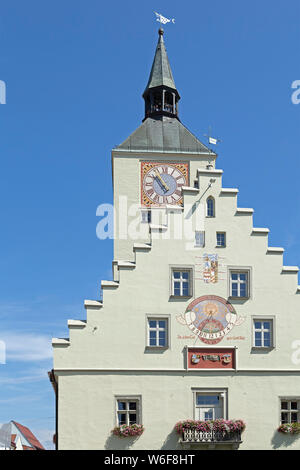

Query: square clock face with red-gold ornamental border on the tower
[141,162,188,206]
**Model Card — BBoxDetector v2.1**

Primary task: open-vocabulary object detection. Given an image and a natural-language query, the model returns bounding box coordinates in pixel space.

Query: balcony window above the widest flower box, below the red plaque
[194,391,226,421]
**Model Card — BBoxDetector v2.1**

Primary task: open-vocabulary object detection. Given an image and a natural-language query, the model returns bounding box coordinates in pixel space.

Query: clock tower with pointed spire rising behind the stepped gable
[112,28,217,260]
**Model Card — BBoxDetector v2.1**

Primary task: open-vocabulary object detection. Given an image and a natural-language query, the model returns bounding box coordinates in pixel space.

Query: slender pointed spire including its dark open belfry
[143,27,180,120]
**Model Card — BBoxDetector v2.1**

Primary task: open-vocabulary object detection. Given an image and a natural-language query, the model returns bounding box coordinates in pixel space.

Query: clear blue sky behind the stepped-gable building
[0,0,300,446]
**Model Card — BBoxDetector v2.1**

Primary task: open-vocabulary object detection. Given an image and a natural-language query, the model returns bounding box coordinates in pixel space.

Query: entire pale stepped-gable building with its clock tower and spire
[50,29,300,450]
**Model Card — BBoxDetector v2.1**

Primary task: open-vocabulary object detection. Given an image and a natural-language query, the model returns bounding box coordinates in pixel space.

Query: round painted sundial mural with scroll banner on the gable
[176,295,245,344]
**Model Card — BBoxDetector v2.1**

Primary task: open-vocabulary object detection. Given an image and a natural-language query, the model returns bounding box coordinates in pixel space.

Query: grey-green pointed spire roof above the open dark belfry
[144,28,176,94]
